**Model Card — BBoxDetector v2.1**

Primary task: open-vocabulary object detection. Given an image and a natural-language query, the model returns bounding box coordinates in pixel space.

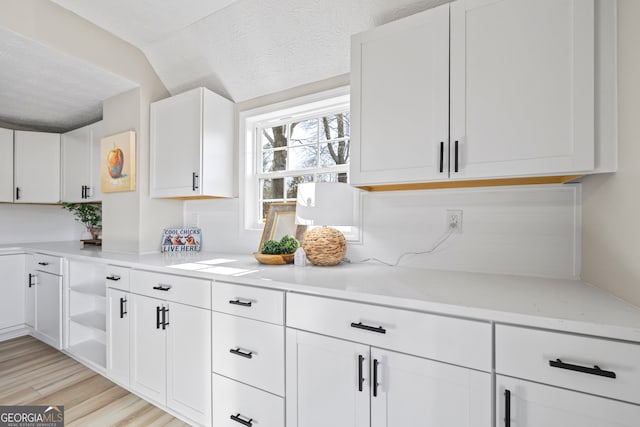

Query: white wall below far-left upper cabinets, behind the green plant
[0,203,84,245]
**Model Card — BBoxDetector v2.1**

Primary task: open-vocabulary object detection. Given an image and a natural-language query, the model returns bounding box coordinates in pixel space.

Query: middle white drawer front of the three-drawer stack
[211,312,284,396]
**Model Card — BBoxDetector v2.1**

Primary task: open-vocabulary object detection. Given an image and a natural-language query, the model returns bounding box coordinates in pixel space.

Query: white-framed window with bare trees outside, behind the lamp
[240,88,351,229]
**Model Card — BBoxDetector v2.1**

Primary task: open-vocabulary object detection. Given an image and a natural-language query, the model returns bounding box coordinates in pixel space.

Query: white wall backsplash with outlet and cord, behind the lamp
[184,184,581,278]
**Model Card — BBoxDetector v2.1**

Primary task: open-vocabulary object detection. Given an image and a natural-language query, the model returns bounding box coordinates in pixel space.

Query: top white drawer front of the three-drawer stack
[211,282,284,325]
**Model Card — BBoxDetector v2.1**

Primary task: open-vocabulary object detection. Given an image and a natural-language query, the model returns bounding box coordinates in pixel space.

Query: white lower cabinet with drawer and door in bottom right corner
[495,324,640,427]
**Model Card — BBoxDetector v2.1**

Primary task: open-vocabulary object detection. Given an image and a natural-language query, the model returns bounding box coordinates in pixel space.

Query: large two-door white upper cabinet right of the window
[351,0,604,186]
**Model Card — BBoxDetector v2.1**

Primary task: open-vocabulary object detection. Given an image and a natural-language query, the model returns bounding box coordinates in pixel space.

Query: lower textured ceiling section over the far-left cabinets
[0,27,136,132]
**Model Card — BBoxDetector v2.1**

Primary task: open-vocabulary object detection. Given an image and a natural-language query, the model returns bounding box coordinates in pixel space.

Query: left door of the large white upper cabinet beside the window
[350,5,449,184]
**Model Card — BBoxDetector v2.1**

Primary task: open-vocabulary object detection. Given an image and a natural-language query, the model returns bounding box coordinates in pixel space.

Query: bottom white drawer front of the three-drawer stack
[212,374,284,427]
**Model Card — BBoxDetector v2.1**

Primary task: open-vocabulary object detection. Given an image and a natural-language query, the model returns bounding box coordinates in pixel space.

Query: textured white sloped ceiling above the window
[53,0,447,102]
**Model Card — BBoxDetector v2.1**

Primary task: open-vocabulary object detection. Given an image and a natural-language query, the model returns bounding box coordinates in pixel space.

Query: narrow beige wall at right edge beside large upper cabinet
[582,0,640,306]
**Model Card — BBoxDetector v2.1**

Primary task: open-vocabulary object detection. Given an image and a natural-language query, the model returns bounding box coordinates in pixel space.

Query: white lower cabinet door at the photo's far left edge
[0,254,25,331]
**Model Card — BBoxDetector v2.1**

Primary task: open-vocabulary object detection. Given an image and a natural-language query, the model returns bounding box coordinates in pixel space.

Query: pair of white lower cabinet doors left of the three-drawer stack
[130,294,211,425]
